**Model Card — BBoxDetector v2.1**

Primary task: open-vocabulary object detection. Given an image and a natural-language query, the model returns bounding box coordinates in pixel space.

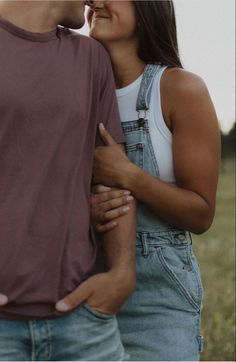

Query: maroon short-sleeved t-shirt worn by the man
[0,18,124,319]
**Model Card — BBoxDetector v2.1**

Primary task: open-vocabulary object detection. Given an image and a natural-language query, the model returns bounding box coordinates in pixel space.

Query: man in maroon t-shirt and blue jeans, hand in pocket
[0,1,135,360]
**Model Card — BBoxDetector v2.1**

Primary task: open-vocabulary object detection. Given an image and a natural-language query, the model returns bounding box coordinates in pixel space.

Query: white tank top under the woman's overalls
[116,66,175,183]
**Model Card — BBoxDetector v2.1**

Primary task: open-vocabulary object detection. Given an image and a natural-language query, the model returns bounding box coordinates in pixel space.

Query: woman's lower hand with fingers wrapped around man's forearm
[91,185,134,233]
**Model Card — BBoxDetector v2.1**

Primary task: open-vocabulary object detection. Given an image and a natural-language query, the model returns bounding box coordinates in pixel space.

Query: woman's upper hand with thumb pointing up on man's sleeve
[93,123,133,188]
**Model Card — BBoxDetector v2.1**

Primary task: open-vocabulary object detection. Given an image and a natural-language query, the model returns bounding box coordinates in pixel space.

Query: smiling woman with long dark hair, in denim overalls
[88,1,220,361]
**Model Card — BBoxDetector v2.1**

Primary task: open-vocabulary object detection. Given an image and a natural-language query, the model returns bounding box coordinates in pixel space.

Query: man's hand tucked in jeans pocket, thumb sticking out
[56,270,135,315]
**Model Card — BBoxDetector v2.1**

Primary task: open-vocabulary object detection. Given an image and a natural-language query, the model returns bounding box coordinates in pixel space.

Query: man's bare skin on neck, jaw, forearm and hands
[0,1,136,314]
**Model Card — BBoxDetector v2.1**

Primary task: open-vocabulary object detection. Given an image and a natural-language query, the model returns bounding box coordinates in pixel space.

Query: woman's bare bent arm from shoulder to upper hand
[94,69,220,233]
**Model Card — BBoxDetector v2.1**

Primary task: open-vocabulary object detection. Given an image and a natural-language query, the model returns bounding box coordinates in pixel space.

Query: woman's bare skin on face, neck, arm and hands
[88,1,220,234]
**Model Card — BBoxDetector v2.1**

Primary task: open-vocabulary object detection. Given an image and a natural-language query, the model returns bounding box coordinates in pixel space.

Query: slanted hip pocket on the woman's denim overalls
[156,245,203,312]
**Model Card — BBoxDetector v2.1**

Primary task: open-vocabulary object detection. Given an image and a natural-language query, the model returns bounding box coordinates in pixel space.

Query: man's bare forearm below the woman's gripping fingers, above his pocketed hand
[101,201,136,278]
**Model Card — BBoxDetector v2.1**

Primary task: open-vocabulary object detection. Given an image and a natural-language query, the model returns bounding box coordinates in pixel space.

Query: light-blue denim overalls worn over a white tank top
[118,64,203,361]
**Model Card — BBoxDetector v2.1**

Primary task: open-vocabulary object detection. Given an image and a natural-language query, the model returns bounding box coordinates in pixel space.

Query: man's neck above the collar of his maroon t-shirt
[0,0,59,33]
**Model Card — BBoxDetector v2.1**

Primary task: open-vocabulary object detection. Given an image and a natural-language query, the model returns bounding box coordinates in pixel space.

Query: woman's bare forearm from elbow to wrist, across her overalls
[119,165,214,234]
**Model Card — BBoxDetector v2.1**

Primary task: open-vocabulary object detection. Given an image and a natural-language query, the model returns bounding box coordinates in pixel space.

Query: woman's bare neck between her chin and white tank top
[106,43,145,88]
